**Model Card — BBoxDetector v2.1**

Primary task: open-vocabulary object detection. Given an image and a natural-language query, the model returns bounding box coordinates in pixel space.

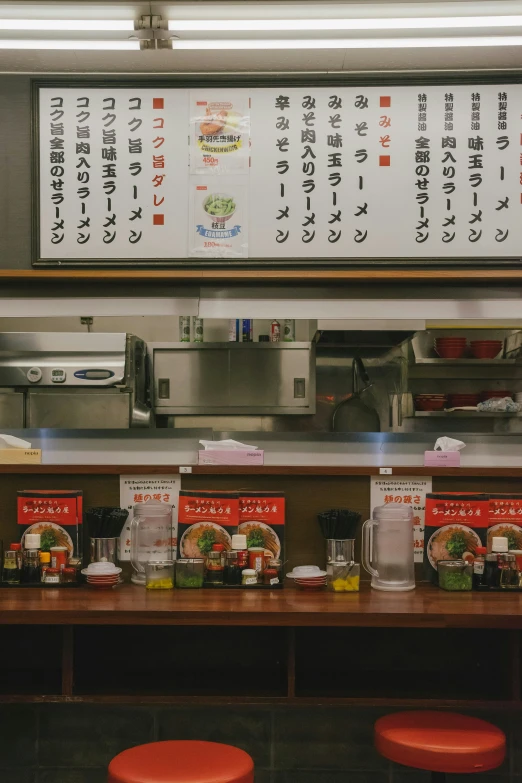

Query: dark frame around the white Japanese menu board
[31,71,522,270]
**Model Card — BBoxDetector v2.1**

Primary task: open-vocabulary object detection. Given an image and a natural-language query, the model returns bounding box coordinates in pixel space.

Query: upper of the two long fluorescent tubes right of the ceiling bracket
[169,16,522,33]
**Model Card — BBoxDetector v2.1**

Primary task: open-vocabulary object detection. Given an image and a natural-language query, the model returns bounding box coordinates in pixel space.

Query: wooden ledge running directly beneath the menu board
[0,267,522,284]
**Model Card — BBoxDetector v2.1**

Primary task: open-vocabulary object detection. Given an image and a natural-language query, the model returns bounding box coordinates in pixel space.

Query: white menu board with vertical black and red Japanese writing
[36,82,522,263]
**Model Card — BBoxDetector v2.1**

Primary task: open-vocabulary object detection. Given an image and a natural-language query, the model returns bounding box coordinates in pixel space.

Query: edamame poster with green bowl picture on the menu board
[189,177,248,258]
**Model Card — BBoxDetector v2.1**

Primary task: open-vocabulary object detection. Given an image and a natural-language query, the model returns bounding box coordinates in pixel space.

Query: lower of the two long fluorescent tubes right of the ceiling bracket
[172,35,522,49]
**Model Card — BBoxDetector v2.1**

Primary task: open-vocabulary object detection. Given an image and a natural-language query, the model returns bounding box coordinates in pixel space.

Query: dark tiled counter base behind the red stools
[0,704,512,783]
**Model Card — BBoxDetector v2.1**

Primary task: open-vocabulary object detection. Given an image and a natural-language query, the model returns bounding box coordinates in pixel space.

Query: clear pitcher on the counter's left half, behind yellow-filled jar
[130,500,172,585]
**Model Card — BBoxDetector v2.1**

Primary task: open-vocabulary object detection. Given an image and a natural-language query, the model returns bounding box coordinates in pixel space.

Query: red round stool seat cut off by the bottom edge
[108,740,254,783]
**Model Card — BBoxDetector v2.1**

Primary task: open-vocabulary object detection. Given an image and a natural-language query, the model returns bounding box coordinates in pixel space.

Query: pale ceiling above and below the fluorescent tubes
[0,0,522,74]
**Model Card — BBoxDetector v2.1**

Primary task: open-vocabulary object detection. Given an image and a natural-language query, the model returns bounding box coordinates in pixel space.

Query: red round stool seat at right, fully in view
[375,711,506,773]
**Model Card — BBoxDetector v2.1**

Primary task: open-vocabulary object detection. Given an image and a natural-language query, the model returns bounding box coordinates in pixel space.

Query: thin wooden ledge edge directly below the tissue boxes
[0,464,522,478]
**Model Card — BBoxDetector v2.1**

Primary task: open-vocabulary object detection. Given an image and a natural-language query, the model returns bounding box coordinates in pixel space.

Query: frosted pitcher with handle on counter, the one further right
[362,503,415,591]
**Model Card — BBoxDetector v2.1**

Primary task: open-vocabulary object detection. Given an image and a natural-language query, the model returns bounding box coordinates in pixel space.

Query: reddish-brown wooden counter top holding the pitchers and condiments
[0,584,522,629]
